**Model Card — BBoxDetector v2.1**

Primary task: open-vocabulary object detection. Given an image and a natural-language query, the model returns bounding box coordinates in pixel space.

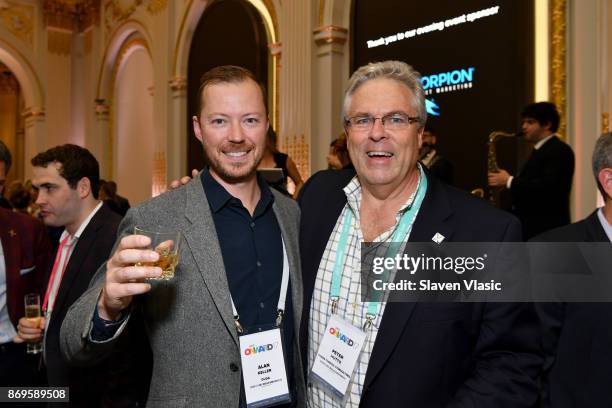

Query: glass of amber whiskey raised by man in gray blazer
[134,227,181,280]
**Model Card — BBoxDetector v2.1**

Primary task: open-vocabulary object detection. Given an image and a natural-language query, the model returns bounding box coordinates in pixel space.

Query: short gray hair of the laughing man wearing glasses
[342,61,427,127]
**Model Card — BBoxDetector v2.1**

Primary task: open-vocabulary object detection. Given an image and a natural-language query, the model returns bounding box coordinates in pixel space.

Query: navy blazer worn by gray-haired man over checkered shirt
[300,170,541,408]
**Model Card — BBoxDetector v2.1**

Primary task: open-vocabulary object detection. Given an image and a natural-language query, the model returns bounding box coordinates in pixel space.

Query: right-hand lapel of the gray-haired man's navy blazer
[364,175,453,388]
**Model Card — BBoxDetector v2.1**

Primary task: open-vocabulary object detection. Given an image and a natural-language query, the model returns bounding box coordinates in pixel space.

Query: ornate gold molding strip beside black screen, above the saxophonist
[550,0,567,140]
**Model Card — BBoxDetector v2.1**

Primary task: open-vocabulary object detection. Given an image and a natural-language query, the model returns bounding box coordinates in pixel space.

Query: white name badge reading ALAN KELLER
[239,328,291,408]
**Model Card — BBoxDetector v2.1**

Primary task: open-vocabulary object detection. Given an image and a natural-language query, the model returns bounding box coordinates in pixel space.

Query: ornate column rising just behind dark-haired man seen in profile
[93,99,113,180]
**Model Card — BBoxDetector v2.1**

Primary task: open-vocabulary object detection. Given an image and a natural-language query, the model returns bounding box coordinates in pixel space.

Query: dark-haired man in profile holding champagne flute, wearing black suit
[18,144,151,406]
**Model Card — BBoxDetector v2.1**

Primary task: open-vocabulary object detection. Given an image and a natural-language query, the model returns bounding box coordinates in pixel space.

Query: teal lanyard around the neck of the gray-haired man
[330,173,427,330]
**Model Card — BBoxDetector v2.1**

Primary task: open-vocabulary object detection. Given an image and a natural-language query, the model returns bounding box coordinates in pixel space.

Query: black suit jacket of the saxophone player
[510,136,574,240]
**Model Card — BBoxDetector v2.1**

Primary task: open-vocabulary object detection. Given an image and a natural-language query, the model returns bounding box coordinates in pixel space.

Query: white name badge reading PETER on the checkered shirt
[311,315,367,398]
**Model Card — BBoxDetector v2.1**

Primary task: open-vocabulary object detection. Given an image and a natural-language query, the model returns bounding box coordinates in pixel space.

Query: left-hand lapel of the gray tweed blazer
[180,177,238,345]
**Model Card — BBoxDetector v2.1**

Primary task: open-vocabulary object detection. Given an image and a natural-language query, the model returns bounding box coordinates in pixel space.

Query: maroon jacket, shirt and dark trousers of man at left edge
[0,207,52,386]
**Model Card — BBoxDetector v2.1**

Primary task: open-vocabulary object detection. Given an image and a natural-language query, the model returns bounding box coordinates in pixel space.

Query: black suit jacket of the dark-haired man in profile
[45,205,150,407]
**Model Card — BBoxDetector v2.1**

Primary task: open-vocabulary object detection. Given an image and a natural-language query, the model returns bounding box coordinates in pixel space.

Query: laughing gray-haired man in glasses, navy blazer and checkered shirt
[299,61,541,408]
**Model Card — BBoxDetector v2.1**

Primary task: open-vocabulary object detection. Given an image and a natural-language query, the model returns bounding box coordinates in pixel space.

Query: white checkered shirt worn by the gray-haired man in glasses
[308,165,425,408]
